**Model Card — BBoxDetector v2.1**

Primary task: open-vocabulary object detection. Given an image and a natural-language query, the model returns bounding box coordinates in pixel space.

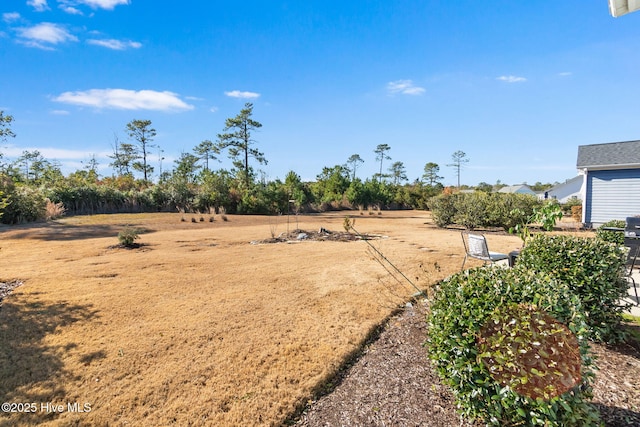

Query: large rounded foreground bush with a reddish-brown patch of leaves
[428,266,599,426]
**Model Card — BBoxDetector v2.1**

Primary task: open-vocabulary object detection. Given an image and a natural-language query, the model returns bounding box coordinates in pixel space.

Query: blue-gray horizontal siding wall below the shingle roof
[585,169,640,227]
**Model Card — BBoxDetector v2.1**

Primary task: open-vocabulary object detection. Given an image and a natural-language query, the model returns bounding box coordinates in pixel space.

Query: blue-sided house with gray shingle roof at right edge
[577,141,640,227]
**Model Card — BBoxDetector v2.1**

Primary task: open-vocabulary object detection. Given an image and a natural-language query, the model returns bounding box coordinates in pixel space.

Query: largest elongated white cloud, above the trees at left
[53,89,194,111]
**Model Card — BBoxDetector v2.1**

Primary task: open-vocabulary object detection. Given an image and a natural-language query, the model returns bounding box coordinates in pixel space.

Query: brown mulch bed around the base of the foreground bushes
[295,301,640,427]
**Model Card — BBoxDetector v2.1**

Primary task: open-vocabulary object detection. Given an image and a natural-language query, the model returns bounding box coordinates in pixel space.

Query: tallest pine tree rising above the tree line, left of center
[218,102,267,189]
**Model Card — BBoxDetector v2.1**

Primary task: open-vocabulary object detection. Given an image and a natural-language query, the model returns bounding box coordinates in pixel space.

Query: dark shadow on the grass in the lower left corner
[0,300,97,427]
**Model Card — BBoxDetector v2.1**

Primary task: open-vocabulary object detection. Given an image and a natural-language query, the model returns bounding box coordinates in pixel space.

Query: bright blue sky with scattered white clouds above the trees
[0,0,640,185]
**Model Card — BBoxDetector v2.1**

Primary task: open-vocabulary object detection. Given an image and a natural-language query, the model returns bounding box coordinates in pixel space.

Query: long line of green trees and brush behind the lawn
[0,103,468,223]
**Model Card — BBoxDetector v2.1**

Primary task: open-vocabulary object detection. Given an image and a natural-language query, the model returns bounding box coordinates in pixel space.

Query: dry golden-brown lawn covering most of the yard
[0,211,520,426]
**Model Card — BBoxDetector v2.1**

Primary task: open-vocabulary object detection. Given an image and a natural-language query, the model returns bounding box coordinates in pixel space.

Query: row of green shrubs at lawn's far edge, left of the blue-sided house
[428,191,542,230]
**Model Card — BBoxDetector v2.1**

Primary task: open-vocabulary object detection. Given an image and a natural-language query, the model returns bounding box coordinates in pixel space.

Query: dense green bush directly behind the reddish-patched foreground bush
[518,234,628,342]
